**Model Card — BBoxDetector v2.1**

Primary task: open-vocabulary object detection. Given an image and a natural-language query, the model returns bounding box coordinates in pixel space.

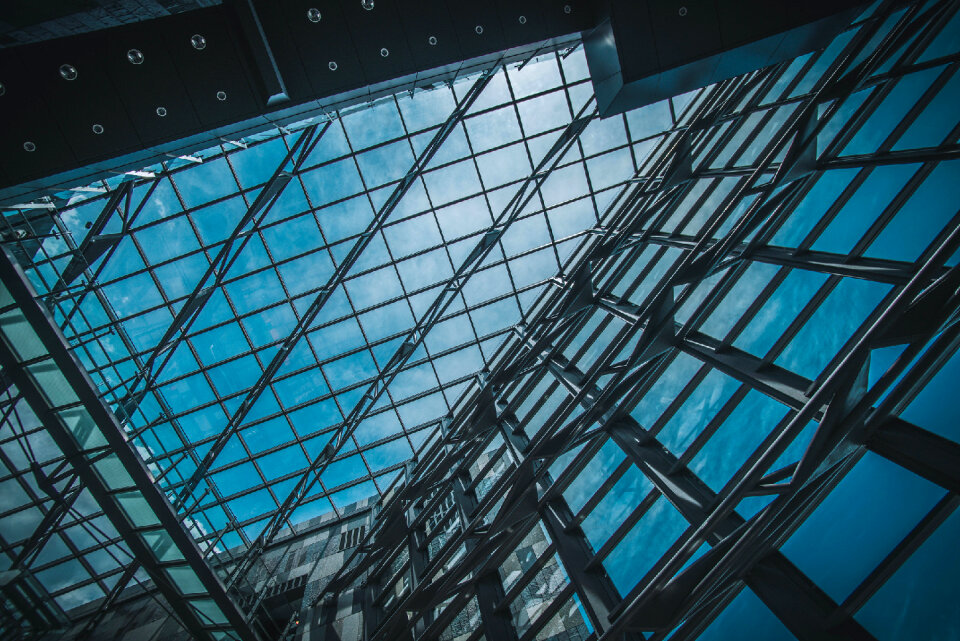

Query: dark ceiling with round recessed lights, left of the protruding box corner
[0,0,592,197]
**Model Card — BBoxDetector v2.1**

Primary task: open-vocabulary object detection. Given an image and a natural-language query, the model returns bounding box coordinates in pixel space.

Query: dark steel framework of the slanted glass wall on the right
[296,3,960,640]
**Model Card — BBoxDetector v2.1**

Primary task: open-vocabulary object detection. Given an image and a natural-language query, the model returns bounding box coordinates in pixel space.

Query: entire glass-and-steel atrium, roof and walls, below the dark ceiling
[0,0,960,641]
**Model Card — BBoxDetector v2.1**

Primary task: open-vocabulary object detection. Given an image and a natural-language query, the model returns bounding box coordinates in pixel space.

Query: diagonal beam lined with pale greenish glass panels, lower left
[0,250,258,641]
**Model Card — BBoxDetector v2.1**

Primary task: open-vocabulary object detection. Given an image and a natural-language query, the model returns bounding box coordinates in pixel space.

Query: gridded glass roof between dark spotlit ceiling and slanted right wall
[11,50,648,548]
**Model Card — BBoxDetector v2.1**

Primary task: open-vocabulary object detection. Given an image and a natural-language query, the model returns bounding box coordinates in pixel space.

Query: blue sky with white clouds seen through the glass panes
[13,7,960,640]
